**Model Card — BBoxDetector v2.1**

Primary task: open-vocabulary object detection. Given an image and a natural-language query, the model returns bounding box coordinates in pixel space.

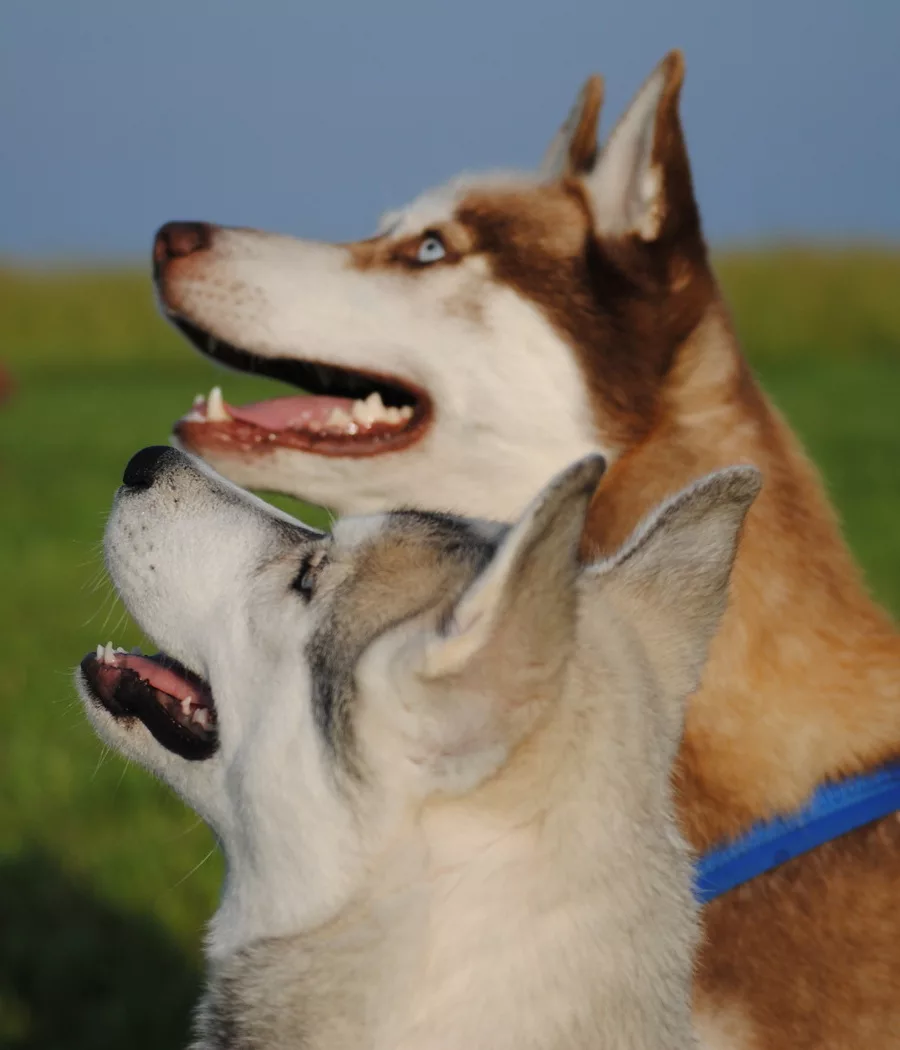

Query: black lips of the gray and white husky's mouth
[81,653,218,761]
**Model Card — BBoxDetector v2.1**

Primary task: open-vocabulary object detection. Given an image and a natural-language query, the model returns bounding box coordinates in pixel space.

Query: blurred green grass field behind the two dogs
[0,250,900,1050]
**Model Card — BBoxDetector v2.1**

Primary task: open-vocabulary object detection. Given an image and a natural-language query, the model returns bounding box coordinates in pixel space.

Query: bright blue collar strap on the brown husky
[694,761,900,904]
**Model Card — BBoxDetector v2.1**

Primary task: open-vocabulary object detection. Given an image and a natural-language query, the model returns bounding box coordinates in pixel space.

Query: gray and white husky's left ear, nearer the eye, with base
[385,456,606,794]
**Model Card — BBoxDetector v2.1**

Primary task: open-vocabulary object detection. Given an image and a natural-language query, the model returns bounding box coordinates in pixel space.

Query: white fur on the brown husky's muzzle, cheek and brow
[165,182,616,519]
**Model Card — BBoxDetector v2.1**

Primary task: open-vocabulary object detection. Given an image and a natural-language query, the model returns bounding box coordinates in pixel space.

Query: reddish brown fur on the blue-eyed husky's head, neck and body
[344,55,900,1050]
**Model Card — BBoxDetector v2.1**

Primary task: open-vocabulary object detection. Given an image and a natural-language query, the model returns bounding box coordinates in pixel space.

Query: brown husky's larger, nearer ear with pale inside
[584,51,699,242]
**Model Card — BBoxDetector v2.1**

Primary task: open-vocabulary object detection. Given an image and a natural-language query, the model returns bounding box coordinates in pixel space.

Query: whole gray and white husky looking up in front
[78,448,759,1050]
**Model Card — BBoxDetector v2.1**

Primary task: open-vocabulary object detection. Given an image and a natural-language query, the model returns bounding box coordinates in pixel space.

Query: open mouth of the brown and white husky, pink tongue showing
[171,317,432,456]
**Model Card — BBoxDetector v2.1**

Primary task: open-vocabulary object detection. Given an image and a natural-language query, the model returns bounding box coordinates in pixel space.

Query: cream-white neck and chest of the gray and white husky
[190,663,695,1050]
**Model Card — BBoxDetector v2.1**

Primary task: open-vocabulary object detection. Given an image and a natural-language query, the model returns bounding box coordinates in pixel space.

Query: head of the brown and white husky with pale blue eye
[154,53,711,518]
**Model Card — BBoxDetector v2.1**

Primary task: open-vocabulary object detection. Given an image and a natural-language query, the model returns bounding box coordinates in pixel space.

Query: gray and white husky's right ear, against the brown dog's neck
[585,466,762,699]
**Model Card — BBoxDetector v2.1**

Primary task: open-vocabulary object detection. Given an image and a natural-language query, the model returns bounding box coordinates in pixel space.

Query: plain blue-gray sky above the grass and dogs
[0,0,900,259]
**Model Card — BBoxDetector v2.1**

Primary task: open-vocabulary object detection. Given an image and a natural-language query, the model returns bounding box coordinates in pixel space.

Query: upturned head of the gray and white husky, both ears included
[78,448,758,974]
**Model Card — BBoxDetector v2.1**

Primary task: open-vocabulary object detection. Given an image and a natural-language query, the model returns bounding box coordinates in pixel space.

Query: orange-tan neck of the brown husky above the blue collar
[586,298,900,848]
